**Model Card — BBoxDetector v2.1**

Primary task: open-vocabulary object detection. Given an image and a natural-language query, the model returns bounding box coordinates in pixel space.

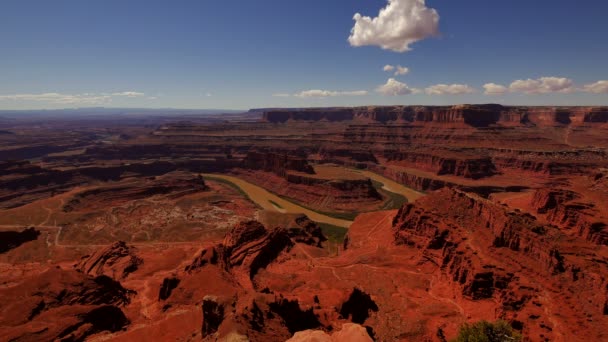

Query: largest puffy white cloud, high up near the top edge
[348,0,439,52]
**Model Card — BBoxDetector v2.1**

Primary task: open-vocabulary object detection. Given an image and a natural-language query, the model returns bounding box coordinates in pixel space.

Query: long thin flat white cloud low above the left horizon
[0,91,151,106]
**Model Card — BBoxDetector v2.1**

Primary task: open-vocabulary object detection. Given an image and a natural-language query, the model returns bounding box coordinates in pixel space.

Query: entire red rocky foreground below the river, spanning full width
[0,189,608,341]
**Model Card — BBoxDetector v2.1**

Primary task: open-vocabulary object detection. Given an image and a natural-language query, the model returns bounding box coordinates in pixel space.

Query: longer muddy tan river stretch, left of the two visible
[203,174,353,228]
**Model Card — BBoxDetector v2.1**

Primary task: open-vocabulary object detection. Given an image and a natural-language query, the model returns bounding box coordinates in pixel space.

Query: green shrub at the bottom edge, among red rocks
[452,321,522,342]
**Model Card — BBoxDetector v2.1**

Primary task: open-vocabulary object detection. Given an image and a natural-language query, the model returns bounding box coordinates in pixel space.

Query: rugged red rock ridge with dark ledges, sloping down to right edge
[393,189,608,339]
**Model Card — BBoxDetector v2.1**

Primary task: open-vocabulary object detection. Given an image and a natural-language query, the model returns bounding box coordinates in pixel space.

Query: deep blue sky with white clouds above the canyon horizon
[0,0,608,109]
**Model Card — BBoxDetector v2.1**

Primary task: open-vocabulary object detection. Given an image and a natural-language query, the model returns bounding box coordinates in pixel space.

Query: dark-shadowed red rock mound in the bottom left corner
[0,268,130,341]
